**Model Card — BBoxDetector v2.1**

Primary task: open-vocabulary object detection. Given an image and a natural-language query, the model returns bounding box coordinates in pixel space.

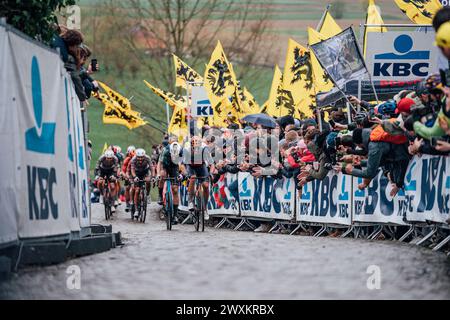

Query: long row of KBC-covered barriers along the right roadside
[180,155,450,249]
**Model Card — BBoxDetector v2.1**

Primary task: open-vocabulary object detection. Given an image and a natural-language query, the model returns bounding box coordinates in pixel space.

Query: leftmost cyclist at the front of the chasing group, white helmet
[94,150,120,212]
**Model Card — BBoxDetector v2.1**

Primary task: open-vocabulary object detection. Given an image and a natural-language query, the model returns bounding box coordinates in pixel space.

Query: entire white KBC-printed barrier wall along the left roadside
[0,26,90,242]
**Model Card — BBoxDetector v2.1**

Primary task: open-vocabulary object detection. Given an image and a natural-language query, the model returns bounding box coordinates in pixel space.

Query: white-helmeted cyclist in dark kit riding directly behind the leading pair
[130,149,152,218]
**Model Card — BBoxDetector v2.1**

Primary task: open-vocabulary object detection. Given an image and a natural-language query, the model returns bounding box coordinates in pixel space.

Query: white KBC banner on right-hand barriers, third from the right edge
[297,173,352,225]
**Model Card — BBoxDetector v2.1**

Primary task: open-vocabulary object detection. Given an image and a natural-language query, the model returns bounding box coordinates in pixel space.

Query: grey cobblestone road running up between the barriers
[0,202,450,299]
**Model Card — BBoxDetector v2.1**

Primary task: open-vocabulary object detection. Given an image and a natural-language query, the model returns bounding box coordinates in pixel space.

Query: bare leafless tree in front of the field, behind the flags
[105,0,273,90]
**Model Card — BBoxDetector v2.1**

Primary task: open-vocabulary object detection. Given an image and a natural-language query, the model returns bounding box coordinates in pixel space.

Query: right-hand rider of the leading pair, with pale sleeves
[182,136,214,220]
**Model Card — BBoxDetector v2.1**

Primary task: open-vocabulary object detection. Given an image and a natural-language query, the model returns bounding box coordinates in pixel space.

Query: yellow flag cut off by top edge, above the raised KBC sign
[395,0,442,24]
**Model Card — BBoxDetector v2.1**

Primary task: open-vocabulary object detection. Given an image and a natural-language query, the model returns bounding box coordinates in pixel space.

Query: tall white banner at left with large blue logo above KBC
[7,33,74,238]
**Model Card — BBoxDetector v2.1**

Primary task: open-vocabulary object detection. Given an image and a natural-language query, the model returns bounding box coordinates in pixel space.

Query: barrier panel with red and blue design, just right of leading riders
[208,173,239,216]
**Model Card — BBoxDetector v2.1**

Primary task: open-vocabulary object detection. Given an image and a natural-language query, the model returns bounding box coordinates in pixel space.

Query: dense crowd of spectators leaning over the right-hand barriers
[167,8,450,229]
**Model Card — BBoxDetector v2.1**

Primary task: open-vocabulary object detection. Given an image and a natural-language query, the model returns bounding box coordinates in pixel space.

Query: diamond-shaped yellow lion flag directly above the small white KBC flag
[204,41,237,111]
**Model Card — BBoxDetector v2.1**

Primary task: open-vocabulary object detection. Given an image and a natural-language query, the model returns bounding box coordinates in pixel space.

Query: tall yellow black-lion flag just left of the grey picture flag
[281,39,316,117]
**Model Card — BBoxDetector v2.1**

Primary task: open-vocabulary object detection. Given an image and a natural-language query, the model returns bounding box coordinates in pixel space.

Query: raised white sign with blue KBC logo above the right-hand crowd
[366,28,440,81]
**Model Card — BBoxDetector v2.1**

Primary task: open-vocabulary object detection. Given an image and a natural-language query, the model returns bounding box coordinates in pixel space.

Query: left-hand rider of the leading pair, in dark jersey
[161,138,182,224]
